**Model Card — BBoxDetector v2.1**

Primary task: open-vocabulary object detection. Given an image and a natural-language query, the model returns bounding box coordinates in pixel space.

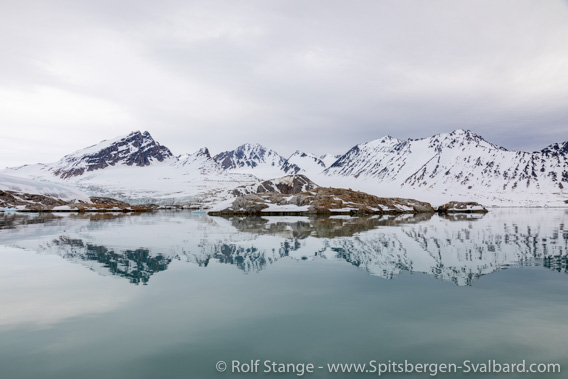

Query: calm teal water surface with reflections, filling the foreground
[0,209,568,379]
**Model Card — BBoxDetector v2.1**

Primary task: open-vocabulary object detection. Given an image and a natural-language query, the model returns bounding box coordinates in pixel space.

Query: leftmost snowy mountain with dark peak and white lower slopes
[4,131,258,203]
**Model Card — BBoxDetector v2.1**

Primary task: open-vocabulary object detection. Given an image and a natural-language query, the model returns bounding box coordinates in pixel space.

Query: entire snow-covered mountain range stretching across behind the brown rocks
[0,130,568,206]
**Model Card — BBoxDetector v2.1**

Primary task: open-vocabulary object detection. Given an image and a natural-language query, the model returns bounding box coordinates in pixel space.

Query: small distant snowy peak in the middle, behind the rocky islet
[213,143,301,179]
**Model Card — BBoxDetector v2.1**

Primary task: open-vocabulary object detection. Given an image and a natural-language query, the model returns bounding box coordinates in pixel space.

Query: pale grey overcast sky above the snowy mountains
[0,0,568,167]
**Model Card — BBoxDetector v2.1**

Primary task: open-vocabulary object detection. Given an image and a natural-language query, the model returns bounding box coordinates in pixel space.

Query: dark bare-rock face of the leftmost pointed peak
[54,131,172,179]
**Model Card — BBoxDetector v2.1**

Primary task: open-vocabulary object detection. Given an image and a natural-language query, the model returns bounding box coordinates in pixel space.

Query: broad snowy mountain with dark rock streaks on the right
[324,130,568,205]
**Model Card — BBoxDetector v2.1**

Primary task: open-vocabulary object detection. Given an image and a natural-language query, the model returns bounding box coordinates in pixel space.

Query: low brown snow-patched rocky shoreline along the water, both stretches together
[0,184,487,217]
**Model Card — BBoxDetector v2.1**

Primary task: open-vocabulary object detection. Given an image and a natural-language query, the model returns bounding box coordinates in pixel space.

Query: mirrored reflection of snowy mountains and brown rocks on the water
[0,209,568,285]
